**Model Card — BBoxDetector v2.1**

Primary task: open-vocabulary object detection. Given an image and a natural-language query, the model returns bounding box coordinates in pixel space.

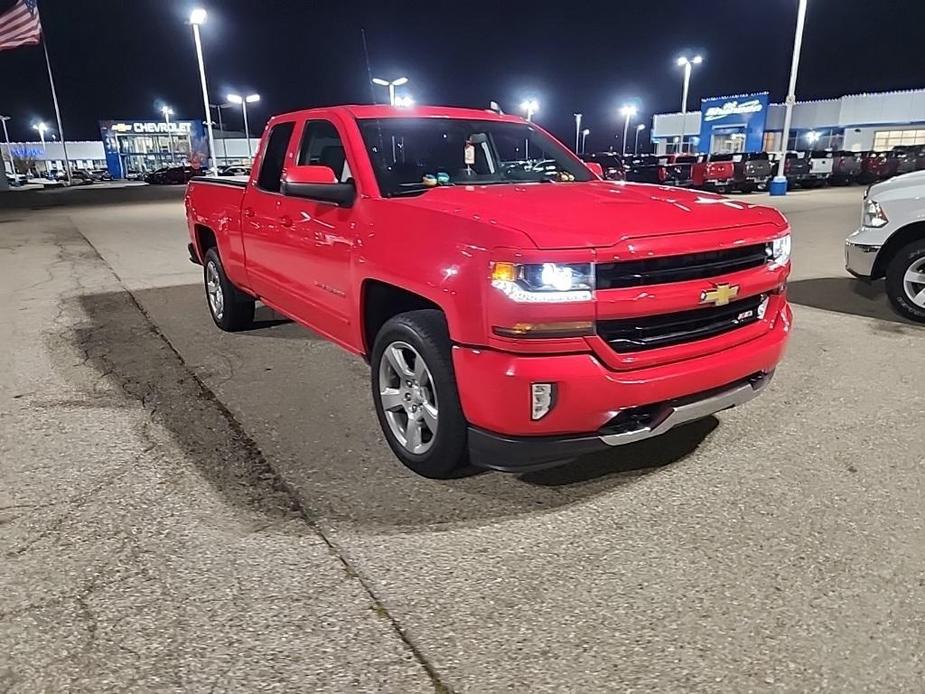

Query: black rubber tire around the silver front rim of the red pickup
[370,309,469,479]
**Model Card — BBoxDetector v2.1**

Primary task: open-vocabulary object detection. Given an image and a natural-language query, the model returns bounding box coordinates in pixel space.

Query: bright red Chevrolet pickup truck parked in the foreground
[186,106,792,477]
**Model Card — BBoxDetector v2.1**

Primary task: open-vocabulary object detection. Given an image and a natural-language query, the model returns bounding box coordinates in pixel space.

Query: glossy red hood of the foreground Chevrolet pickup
[393,181,786,249]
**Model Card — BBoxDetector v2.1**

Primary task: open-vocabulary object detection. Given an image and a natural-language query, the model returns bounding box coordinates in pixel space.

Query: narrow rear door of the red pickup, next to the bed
[241,121,295,310]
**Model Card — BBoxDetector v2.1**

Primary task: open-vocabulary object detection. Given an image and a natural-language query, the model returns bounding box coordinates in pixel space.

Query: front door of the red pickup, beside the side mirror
[270,118,357,342]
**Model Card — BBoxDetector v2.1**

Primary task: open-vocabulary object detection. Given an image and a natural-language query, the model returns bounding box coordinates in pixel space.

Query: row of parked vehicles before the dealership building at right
[582,147,925,193]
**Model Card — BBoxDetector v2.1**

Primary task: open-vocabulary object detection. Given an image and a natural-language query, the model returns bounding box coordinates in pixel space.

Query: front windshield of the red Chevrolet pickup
[359,118,594,197]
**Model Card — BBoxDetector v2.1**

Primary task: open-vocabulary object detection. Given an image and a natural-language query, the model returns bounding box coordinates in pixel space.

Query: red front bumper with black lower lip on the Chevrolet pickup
[453,301,793,469]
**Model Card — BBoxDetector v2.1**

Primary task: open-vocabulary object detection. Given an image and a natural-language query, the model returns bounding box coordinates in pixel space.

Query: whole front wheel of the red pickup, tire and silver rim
[370,309,468,479]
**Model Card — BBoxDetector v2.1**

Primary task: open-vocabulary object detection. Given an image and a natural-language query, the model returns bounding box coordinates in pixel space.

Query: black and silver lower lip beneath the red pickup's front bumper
[469,371,774,472]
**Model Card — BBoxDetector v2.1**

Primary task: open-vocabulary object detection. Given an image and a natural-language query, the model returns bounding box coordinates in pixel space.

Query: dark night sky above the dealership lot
[0,0,925,149]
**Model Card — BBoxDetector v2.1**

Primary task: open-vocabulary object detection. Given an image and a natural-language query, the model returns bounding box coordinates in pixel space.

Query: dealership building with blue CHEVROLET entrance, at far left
[0,120,259,178]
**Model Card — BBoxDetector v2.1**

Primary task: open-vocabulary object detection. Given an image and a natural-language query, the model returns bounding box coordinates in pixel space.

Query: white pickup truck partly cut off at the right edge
[845,171,925,323]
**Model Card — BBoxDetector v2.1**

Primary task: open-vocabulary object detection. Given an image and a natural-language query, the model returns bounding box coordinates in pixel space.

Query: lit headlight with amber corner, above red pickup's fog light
[491,263,594,303]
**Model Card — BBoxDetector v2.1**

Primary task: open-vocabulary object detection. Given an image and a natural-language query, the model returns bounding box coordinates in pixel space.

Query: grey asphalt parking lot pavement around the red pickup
[0,187,925,692]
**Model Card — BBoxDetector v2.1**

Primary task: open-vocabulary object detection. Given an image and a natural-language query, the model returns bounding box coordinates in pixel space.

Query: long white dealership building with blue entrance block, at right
[651,89,925,154]
